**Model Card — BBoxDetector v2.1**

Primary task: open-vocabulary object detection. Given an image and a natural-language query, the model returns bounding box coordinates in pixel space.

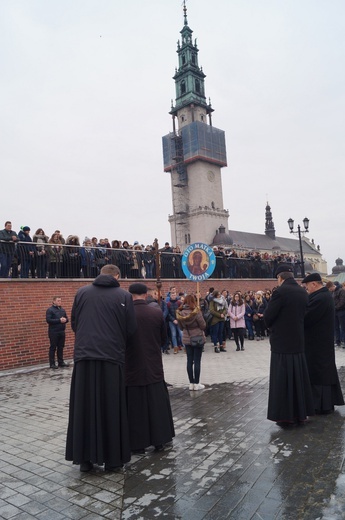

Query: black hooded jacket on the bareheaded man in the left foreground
[71,274,137,365]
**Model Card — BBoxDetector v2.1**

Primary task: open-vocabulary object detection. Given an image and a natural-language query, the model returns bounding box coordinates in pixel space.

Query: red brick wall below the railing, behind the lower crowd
[0,279,276,370]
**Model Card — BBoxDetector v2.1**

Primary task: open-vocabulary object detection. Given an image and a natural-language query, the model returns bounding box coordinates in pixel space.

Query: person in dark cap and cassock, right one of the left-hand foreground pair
[125,283,175,453]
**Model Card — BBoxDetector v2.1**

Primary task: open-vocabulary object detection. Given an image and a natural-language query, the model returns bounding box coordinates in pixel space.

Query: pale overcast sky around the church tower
[0,0,345,272]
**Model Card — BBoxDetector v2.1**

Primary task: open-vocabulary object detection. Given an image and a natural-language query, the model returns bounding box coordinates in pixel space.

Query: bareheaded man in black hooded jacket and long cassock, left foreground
[66,264,136,471]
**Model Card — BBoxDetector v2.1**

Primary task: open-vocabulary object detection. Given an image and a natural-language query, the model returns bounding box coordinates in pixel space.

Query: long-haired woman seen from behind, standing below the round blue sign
[176,294,206,390]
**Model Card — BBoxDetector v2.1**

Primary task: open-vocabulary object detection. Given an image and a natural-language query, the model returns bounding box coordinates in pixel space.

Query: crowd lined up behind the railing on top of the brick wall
[0,221,312,279]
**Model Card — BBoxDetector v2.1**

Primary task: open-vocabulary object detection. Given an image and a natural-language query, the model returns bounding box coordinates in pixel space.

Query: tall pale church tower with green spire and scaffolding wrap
[163,2,229,250]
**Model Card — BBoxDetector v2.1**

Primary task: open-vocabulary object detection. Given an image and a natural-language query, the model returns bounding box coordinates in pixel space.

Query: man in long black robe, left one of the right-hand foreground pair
[264,263,315,427]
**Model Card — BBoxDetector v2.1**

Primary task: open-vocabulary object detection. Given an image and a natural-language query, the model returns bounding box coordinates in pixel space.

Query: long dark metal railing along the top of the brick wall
[0,241,301,279]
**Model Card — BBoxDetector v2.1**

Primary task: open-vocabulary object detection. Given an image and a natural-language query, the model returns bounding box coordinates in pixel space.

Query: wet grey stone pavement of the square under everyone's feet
[0,340,345,520]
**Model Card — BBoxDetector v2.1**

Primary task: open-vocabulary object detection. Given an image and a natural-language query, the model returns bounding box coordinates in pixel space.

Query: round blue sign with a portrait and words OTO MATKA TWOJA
[182,242,216,282]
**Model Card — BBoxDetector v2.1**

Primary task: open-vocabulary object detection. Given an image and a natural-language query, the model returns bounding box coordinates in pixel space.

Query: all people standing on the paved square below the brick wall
[36,263,345,471]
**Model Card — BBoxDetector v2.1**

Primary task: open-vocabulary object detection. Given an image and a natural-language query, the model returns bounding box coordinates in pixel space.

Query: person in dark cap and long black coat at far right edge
[302,273,344,414]
